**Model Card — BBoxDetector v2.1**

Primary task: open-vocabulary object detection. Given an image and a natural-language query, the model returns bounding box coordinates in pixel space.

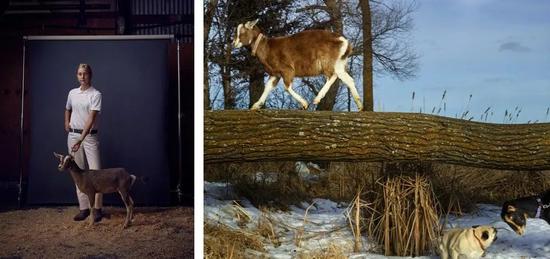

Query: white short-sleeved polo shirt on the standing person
[65,86,101,129]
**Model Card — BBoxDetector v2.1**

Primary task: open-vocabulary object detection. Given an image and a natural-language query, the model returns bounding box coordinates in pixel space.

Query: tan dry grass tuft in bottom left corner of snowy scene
[204,223,265,259]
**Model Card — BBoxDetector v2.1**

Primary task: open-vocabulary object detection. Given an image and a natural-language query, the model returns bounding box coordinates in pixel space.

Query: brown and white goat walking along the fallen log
[233,20,363,110]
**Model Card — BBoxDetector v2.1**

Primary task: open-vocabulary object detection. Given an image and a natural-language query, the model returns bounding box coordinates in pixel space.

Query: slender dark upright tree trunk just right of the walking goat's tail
[359,0,374,111]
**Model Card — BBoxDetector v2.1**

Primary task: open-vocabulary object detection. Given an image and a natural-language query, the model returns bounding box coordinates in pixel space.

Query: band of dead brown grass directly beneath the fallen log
[205,162,550,214]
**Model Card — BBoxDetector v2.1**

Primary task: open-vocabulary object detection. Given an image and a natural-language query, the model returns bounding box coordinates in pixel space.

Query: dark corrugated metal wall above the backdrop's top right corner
[132,0,193,43]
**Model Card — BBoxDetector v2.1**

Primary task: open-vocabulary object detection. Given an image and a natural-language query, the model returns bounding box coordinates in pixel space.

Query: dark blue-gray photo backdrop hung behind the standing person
[25,39,172,205]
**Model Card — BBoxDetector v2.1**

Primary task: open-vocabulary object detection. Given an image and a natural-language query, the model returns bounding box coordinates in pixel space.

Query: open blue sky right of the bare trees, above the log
[374,0,550,123]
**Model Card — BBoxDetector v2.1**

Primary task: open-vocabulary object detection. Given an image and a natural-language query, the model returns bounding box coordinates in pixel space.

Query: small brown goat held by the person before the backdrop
[53,152,137,228]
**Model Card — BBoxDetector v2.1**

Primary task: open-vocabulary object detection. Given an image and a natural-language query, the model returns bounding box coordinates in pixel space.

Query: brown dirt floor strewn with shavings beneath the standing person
[0,207,193,258]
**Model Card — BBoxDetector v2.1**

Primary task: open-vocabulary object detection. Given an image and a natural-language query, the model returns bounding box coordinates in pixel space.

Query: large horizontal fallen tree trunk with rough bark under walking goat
[204,110,550,170]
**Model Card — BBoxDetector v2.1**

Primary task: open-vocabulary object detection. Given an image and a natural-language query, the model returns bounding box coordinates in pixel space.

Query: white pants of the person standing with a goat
[67,132,103,210]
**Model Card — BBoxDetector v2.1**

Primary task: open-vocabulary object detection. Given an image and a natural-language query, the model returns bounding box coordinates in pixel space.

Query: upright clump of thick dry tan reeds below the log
[363,175,440,256]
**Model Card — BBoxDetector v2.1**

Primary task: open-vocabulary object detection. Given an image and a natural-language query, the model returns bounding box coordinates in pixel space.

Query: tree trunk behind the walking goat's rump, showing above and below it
[317,0,344,111]
